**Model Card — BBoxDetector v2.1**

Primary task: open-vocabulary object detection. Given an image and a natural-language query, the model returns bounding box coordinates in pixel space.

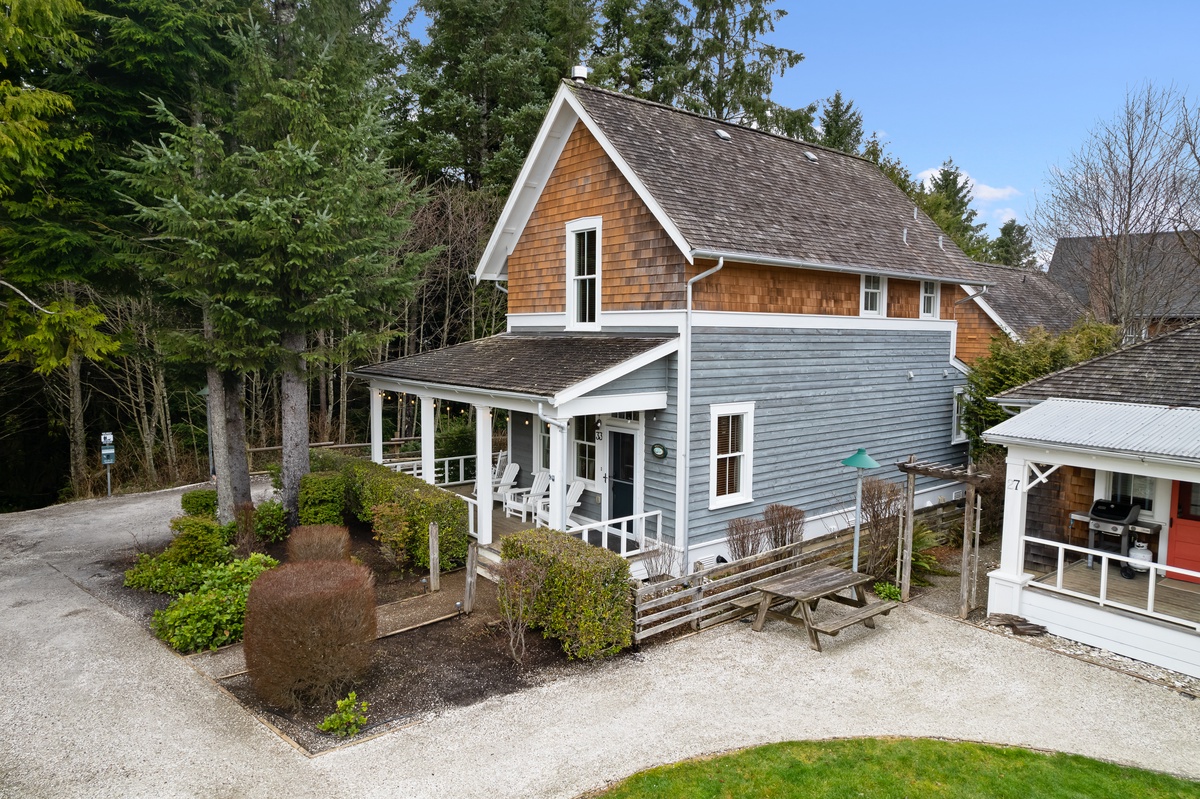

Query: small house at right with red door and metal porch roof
[984,324,1200,677]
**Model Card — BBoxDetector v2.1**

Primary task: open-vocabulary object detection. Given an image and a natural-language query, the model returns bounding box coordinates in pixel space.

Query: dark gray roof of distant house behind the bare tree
[1046,230,1200,319]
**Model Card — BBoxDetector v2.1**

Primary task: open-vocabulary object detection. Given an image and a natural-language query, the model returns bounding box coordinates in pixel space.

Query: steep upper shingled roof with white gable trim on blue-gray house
[476,83,986,283]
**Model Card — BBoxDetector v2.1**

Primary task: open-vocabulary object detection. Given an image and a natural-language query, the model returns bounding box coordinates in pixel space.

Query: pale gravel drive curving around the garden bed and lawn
[0,491,1200,798]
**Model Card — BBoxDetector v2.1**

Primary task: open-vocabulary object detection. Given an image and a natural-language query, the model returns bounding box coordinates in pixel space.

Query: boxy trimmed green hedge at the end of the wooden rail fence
[500,528,634,659]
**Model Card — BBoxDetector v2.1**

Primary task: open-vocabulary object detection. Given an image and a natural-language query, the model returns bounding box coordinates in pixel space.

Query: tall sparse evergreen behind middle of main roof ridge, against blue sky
[680,0,816,138]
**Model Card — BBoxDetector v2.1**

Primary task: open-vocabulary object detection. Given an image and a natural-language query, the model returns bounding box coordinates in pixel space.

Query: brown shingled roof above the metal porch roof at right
[995,324,1200,408]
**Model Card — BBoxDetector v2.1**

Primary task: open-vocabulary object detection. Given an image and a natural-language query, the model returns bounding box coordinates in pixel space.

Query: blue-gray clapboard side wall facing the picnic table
[689,328,966,543]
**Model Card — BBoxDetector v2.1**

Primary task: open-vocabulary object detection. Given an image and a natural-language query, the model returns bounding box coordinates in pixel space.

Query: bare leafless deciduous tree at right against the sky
[1033,85,1200,338]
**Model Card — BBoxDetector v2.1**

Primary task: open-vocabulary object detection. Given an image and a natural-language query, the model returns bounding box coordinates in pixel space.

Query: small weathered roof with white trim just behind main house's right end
[976,264,1086,336]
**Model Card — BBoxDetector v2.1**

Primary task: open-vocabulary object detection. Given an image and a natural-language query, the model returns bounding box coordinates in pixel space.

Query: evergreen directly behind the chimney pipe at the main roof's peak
[589,0,688,104]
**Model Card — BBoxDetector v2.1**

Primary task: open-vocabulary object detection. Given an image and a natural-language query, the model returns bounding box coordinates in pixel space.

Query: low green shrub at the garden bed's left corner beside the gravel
[125,516,233,594]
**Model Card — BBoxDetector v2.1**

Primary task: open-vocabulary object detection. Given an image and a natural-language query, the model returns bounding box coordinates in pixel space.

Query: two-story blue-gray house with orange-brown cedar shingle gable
[356,83,991,569]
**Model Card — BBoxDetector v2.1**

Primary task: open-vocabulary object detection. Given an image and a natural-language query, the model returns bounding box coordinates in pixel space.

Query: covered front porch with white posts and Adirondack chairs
[356,334,678,557]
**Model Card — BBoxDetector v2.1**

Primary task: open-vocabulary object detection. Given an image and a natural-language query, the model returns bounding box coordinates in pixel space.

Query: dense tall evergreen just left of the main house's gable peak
[396,0,595,192]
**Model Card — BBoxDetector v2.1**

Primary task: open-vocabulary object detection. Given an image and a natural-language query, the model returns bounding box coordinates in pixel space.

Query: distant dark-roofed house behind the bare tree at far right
[1046,232,1200,337]
